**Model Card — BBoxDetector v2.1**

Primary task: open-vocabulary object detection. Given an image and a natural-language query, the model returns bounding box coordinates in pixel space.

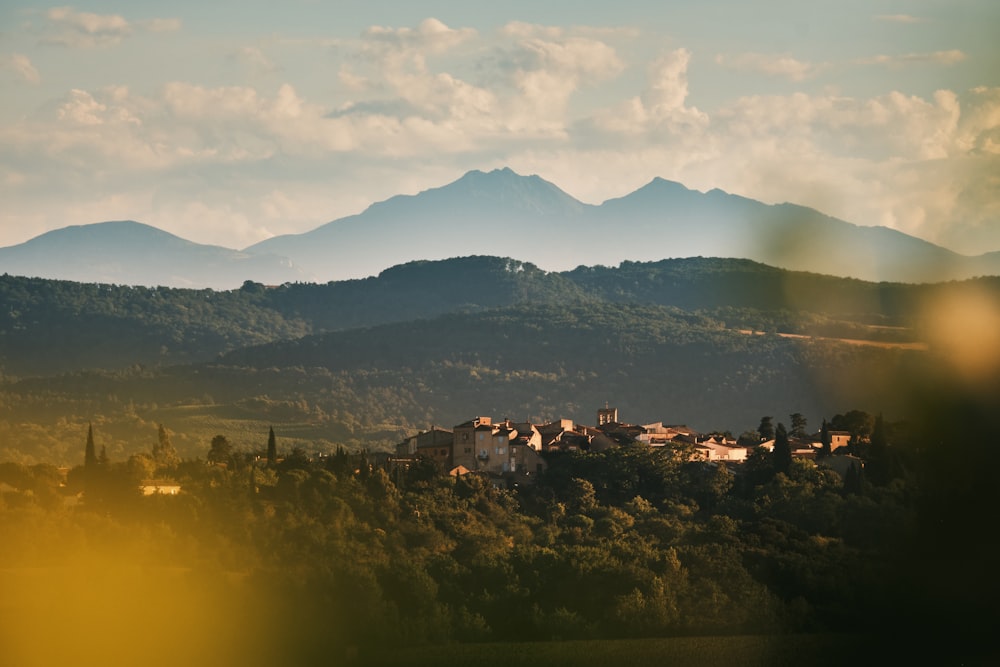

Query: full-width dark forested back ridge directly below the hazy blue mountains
[0,256,1000,377]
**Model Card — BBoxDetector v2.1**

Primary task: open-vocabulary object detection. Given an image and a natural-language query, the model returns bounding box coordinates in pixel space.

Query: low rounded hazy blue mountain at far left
[0,220,305,289]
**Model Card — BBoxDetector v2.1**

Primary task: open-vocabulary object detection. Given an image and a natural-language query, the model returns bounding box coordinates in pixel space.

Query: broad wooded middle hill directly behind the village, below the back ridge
[0,302,929,461]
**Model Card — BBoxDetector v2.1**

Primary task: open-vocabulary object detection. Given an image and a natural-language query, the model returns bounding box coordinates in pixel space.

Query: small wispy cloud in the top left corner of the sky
[43,7,181,49]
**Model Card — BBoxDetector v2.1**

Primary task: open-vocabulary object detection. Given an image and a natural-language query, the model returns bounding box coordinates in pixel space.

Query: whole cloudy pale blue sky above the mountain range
[0,0,1000,254]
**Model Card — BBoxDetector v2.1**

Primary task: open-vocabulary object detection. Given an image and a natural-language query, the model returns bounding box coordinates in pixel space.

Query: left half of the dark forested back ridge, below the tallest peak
[0,257,587,376]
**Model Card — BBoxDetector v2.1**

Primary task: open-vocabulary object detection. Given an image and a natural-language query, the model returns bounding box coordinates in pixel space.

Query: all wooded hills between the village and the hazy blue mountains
[0,257,1000,464]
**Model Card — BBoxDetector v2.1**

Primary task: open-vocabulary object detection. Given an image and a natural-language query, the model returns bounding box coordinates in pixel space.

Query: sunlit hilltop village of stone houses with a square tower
[387,407,863,486]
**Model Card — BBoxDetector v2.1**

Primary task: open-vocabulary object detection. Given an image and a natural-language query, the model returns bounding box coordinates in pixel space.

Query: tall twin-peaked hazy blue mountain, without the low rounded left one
[246,169,1000,282]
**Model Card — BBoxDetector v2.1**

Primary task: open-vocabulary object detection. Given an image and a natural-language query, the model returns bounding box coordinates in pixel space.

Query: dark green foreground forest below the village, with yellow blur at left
[0,394,996,665]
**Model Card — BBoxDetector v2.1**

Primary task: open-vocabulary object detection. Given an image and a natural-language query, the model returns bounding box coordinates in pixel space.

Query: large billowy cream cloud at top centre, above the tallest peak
[331,19,623,142]
